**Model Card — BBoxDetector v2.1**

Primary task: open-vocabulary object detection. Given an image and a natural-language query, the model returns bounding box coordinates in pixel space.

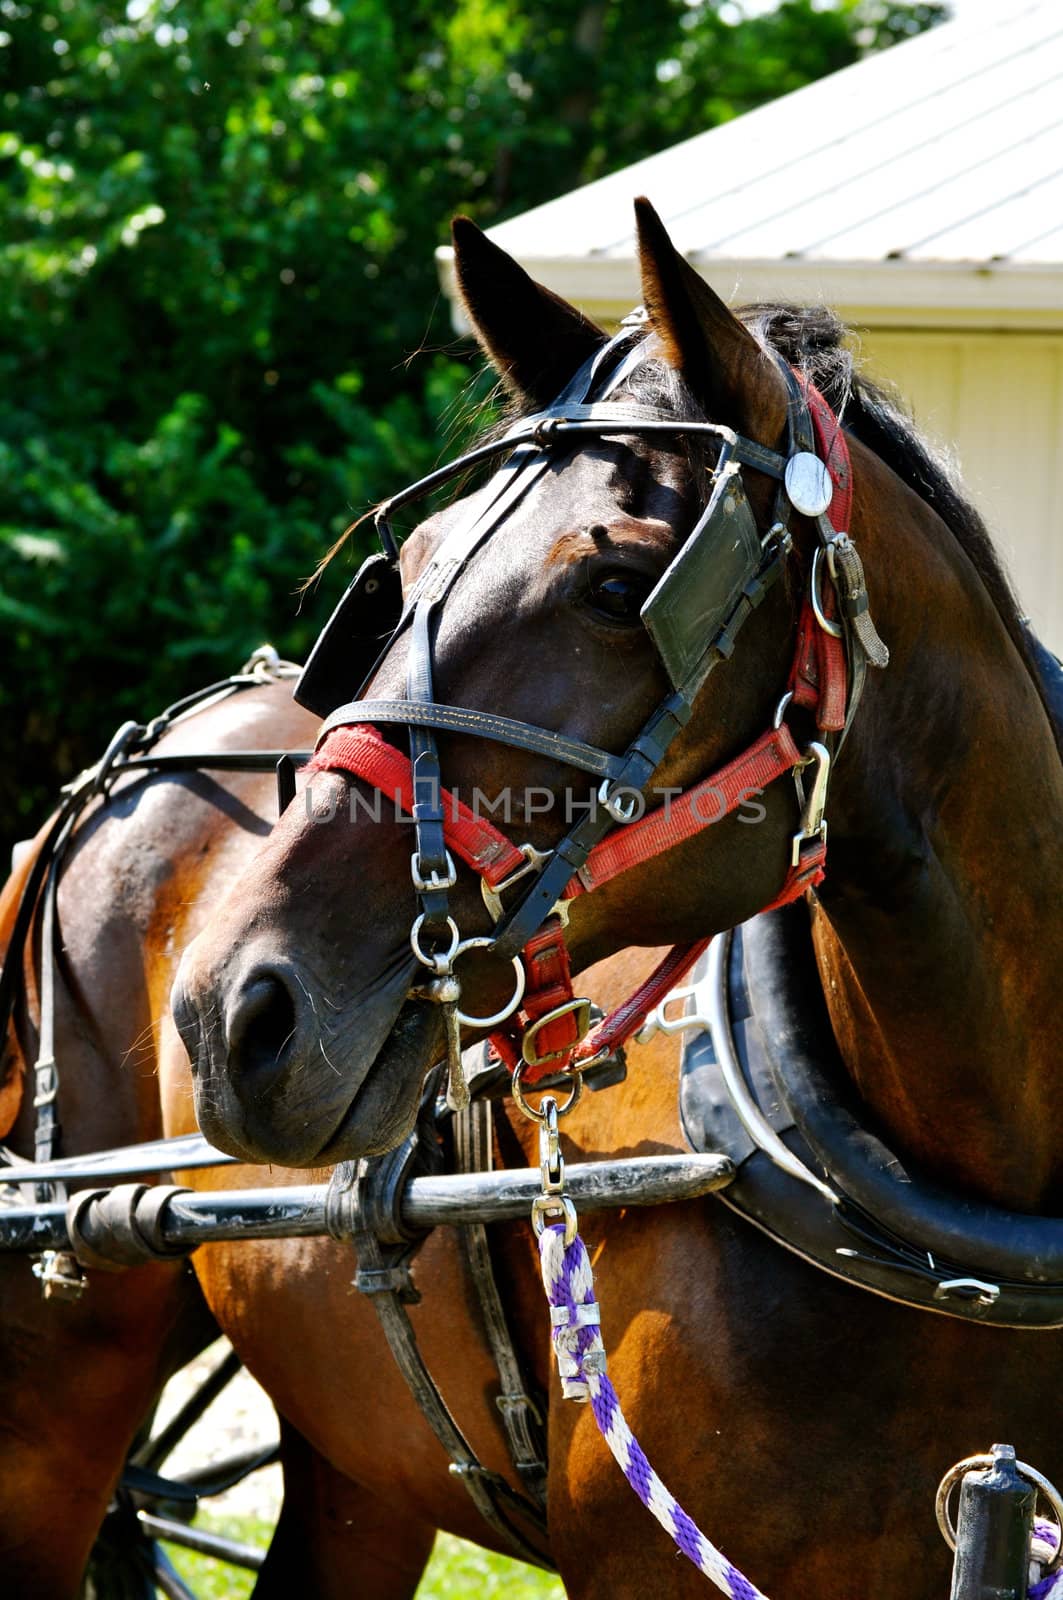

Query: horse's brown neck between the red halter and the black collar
[815,462,1063,1210]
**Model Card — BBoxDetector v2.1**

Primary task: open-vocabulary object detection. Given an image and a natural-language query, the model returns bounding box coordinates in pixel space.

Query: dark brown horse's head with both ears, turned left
[174,202,883,1165]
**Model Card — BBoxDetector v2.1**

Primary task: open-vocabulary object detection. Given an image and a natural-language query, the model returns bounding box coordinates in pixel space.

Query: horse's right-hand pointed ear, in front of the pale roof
[636,198,788,445]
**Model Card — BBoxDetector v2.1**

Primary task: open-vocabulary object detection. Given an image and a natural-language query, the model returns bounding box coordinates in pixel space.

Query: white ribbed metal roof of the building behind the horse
[480,0,1063,269]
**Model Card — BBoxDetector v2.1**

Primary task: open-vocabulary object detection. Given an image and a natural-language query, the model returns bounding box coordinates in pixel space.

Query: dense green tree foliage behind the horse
[0,0,943,832]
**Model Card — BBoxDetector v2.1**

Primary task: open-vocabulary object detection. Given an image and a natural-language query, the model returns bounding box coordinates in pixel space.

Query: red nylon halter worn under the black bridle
[306,384,852,1085]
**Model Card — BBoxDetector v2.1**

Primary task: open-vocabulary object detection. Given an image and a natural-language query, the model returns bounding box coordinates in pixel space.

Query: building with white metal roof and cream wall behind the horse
[440,0,1063,651]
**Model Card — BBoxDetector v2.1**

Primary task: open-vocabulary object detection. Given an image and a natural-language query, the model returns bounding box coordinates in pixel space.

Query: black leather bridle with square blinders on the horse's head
[295,326,860,957]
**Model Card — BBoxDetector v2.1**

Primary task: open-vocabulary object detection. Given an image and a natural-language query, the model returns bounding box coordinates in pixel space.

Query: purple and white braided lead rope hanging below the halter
[540,1224,767,1600]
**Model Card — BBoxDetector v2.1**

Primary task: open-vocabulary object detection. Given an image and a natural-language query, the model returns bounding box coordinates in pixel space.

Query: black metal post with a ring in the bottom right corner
[949,1445,1037,1600]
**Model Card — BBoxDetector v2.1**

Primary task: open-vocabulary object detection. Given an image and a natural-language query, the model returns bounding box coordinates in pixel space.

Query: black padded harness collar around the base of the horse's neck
[672,906,1063,1328]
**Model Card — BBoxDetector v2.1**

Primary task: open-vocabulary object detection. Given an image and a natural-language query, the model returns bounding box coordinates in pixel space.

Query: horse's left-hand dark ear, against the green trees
[451,216,605,406]
